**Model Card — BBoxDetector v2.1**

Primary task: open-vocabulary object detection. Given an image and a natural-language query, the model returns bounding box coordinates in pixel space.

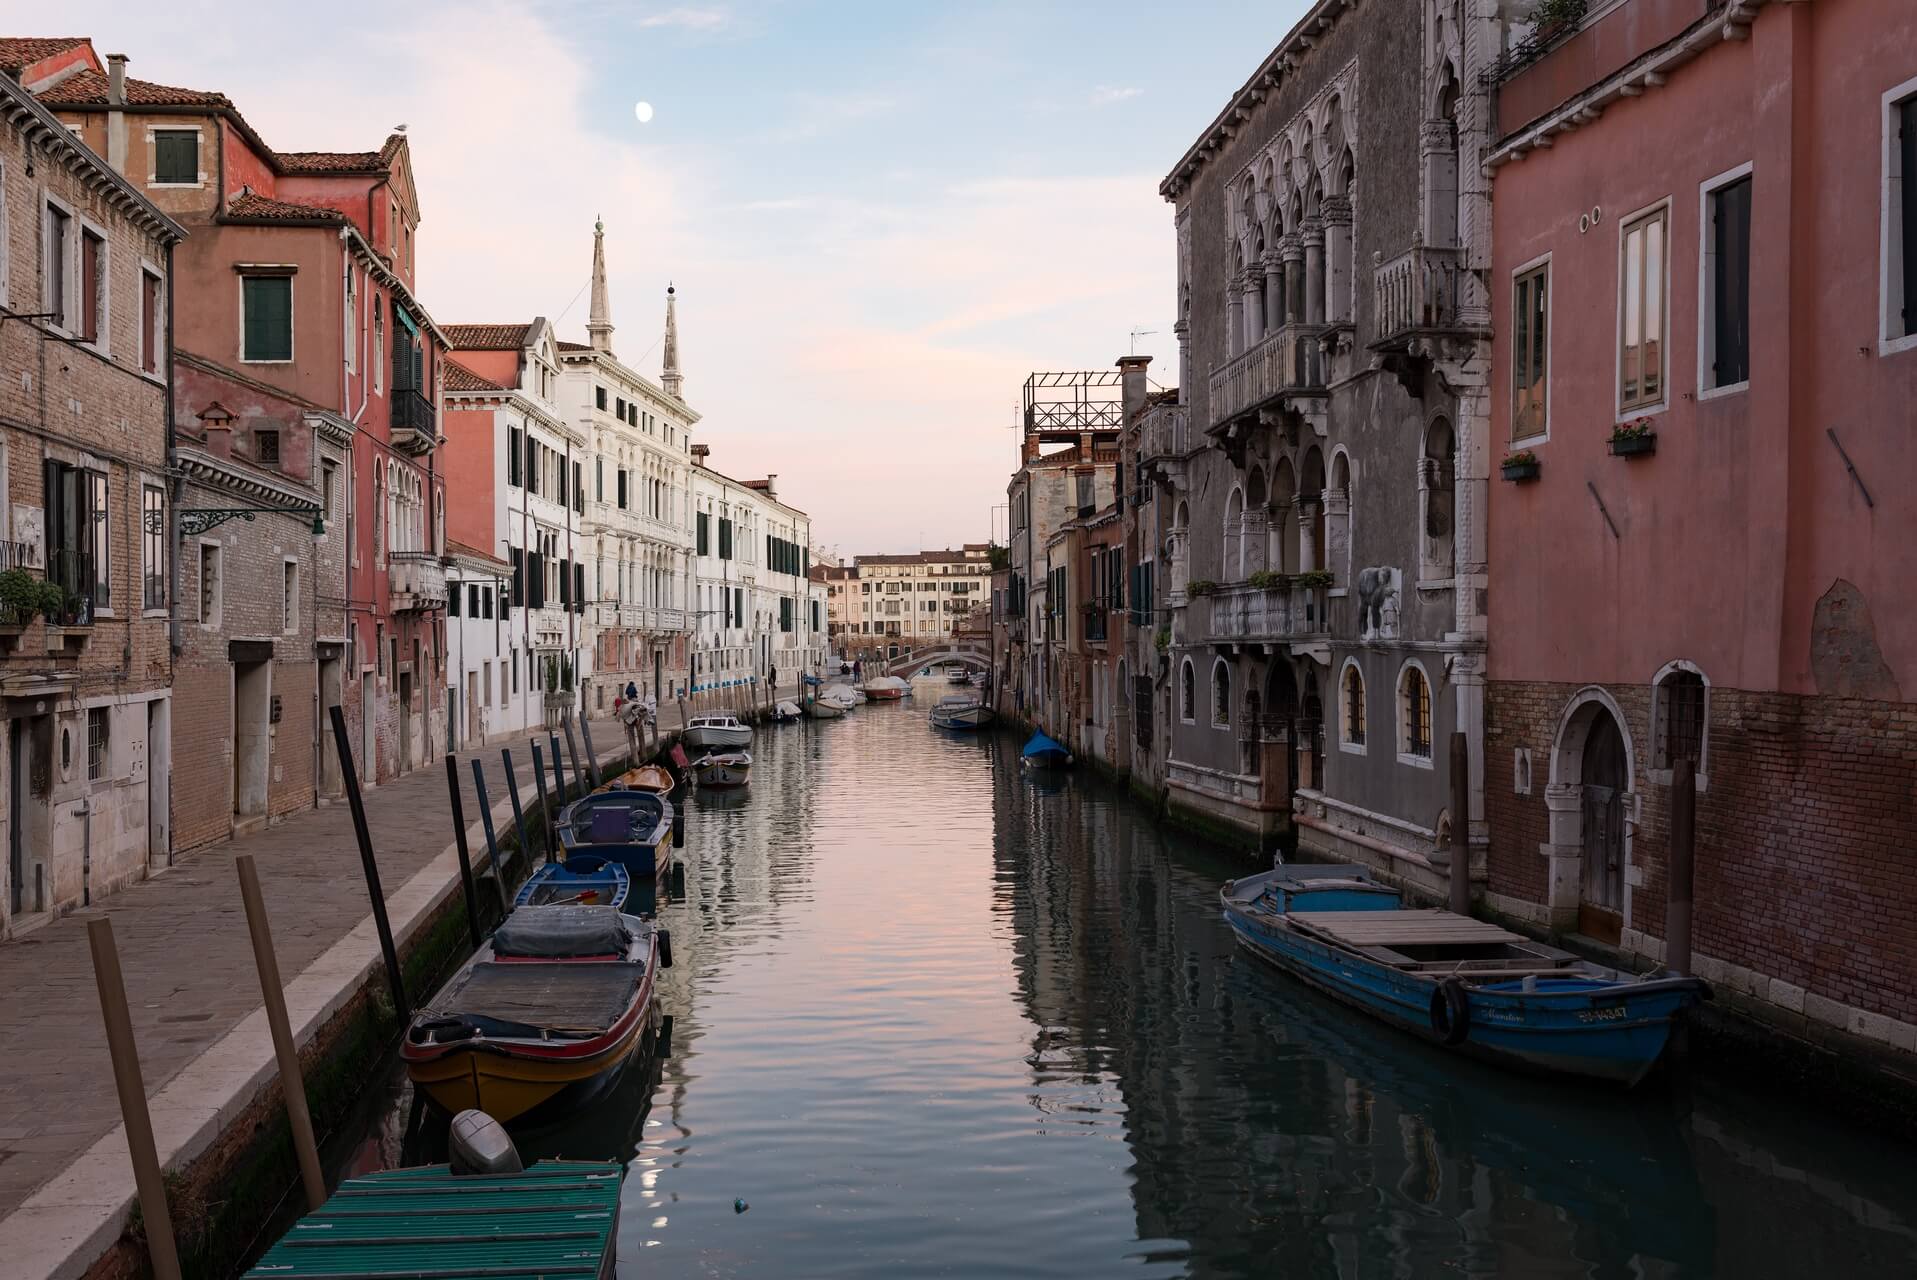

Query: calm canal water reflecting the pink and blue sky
[360,680,1917,1280]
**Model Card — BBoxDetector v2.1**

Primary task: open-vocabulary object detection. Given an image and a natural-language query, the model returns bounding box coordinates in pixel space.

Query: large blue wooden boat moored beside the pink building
[1219,864,1710,1086]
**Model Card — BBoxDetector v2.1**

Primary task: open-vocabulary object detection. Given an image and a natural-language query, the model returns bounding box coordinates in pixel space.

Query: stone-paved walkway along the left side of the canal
[0,707,701,1219]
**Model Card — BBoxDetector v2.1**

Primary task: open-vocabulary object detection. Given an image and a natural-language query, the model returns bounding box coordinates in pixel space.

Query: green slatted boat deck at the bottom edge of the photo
[245,1159,625,1280]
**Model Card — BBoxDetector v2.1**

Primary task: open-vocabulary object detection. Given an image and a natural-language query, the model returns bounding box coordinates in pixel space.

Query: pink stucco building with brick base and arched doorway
[1486,0,1917,1050]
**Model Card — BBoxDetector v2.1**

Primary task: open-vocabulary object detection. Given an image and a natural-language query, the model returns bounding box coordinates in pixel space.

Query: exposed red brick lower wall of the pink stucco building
[1486,682,1917,1021]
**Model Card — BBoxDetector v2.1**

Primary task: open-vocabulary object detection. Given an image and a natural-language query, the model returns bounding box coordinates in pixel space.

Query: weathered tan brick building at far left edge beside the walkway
[0,59,184,937]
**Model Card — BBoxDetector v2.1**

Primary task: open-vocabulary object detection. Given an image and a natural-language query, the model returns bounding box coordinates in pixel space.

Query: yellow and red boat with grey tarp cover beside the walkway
[399,906,673,1121]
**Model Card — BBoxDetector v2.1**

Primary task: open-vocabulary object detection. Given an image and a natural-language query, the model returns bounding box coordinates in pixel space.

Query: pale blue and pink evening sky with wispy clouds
[18,0,1305,556]
